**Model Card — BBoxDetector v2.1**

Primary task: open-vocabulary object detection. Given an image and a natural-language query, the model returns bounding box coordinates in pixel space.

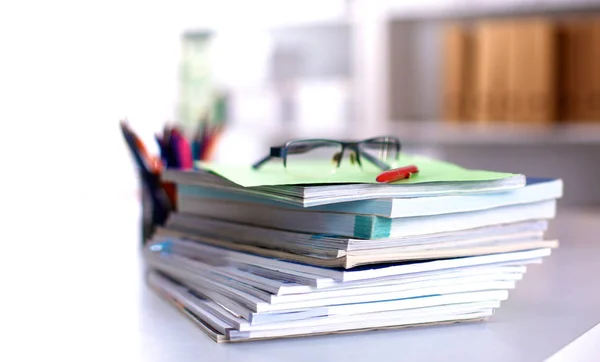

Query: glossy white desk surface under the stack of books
[3,202,600,362]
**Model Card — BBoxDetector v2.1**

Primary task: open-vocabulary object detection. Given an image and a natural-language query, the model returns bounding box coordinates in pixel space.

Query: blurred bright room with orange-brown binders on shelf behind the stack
[0,0,600,210]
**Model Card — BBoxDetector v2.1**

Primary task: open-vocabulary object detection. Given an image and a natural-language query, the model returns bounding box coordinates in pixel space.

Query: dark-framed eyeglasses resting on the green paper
[252,136,401,174]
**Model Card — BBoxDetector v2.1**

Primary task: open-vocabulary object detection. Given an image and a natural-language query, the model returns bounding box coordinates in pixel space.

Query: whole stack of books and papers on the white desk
[144,155,562,342]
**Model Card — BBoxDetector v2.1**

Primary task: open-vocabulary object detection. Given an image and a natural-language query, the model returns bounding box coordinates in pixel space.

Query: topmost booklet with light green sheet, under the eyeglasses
[163,155,525,207]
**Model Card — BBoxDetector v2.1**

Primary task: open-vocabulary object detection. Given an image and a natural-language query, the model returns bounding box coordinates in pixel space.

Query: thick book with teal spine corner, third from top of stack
[179,199,556,239]
